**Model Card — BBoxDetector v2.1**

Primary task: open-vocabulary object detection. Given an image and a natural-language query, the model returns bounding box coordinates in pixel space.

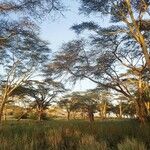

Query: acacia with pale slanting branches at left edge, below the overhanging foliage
[0,26,50,120]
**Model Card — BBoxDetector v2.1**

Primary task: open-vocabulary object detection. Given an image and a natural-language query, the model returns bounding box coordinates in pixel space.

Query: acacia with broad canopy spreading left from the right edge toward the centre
[47,37,149,121]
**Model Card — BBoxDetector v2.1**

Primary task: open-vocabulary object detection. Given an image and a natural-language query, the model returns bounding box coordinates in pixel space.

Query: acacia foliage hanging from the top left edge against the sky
[0,0,63,17]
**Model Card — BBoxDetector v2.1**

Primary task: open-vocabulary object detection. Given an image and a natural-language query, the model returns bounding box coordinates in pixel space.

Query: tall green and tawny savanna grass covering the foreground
[0,120,150,150]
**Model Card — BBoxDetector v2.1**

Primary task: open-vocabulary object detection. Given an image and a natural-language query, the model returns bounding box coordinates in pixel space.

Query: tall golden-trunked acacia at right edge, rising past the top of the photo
[72,0,150,121]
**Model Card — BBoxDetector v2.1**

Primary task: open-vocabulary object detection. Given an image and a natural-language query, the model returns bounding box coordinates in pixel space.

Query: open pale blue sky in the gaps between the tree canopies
[40,0,108,91]
